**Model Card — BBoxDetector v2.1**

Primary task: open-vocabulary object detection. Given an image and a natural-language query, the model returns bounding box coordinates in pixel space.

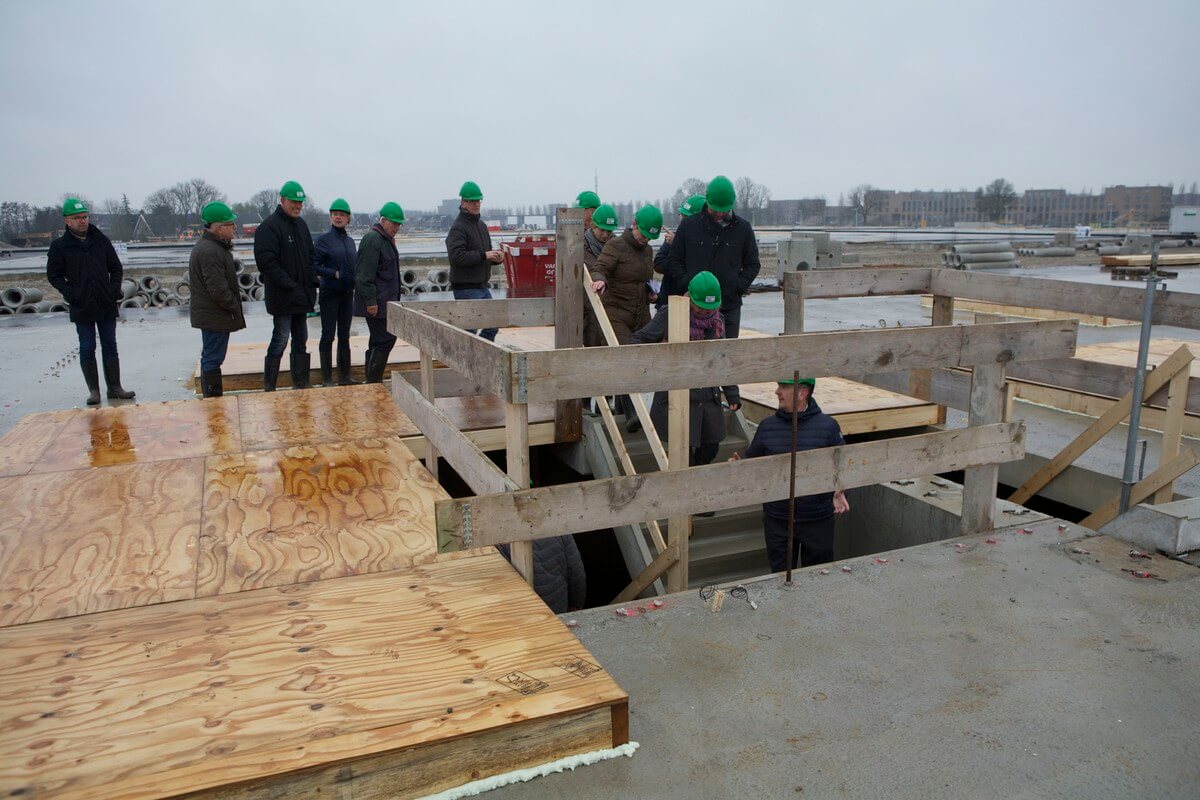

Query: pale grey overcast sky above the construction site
[0,0,1200,209]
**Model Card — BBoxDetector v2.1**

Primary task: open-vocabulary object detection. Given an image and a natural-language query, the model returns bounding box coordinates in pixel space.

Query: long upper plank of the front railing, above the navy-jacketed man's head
[524,320,1079,401]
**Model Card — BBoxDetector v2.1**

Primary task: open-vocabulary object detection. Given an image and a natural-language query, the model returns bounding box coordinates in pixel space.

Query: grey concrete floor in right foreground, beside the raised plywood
[490,521,1200,800]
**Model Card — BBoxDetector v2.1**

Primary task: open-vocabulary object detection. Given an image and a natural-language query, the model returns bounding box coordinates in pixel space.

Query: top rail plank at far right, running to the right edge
[930,270,1200,329]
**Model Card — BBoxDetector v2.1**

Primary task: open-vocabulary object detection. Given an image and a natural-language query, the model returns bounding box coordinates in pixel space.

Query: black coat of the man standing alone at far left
[46,225,125,323]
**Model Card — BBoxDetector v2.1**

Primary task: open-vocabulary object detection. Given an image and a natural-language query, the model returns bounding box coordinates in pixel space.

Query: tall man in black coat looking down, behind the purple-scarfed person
[662,175,761,339]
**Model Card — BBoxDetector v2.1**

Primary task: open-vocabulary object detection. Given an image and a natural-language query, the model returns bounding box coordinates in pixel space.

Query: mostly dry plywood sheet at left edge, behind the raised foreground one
[0,458,204,625]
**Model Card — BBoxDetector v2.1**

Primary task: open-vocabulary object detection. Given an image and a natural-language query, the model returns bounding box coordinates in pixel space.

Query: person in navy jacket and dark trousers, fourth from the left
[312,198,359,386]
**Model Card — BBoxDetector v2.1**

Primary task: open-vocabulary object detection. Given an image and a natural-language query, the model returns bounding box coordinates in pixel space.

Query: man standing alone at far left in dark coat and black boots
[46,197,133,405]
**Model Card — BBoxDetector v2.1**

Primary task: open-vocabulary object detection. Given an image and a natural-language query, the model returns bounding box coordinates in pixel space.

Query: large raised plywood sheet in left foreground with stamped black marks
[0,553,626,799]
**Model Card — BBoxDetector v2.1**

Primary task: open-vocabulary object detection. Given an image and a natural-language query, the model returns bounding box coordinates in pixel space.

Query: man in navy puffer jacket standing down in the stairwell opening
[730,378,850,572]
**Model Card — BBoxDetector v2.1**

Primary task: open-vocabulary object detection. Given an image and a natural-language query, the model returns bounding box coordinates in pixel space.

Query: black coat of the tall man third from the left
[254,205,317,314]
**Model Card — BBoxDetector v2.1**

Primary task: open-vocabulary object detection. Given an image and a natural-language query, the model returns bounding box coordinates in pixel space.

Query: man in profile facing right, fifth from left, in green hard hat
[354,203,404,384]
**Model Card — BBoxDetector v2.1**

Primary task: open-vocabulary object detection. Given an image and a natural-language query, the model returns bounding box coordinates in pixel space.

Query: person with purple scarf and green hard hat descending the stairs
[631,272,742,460]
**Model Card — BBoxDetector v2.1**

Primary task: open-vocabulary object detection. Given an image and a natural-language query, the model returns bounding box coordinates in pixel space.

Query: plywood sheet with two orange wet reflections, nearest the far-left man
[30,397,241,473]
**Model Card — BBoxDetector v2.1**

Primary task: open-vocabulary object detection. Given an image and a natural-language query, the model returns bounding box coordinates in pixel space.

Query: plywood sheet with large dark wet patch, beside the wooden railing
[196,437,448,596]
